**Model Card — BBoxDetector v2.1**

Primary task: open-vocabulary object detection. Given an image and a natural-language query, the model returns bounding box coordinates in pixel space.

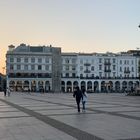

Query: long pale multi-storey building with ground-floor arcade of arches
[6,44,140,92]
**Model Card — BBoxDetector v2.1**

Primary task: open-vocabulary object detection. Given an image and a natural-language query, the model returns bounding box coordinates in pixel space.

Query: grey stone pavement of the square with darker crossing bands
[0,93,140,140]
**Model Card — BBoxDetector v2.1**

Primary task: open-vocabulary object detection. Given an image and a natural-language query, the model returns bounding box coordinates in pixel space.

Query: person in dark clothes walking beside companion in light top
[73,86,82,112]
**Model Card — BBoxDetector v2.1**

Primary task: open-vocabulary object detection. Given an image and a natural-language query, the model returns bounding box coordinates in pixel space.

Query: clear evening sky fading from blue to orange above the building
[0,0,140,73]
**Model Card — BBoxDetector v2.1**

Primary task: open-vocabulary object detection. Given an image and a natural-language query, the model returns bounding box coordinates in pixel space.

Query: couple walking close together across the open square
[73,86,87,112]
